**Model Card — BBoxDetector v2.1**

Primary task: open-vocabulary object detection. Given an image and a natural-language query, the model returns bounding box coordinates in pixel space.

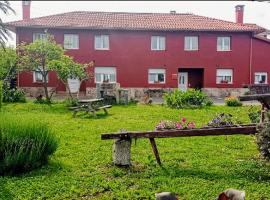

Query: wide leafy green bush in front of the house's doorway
[164,89,213,108]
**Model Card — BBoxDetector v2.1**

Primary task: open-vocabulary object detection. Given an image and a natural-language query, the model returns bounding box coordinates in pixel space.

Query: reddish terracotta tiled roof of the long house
[7,11,264,32]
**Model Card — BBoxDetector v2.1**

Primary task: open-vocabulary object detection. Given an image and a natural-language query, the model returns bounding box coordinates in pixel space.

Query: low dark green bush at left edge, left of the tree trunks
[3,86,26,103]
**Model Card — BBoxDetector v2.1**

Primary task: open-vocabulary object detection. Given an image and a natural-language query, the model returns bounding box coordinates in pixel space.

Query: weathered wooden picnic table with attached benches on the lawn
[69,98,112,117]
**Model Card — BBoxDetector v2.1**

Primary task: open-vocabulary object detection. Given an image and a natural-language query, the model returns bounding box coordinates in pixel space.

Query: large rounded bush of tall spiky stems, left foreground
[0,114,58,175]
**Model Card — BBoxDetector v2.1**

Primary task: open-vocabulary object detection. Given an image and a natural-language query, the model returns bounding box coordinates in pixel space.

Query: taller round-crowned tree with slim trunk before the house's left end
[17,34,64,103]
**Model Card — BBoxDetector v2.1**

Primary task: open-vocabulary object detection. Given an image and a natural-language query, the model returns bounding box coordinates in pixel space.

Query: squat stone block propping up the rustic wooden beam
[112,139,131,166]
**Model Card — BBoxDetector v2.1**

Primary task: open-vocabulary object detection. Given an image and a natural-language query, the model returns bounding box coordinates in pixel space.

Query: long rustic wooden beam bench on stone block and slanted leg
[101,124,256,166]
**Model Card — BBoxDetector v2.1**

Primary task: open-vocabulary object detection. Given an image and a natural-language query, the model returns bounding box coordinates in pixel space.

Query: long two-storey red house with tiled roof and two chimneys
[5,1,270,97]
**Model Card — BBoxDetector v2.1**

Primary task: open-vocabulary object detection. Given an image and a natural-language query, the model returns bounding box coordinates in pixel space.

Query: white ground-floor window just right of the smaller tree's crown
[95,67,116,83]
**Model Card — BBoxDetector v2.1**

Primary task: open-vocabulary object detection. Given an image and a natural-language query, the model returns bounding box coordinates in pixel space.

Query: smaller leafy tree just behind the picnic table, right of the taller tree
[50,55,94,99]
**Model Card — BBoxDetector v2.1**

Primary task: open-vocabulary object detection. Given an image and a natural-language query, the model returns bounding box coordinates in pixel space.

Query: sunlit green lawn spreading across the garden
[0,103,270,200]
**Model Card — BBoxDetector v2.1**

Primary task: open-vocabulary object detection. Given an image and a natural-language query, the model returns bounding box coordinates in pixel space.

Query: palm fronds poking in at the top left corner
[0,1,15,48]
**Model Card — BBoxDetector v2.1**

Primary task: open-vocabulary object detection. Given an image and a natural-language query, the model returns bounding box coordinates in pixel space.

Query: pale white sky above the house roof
[0,1,270,45]
